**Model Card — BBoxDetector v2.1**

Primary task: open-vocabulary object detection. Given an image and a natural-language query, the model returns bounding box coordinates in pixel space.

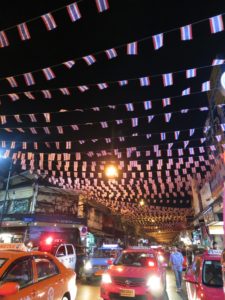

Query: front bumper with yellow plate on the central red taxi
[100,284,161,300]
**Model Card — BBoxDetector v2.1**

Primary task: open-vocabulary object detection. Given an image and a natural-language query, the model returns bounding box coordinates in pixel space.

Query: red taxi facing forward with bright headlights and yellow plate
[100,248,167,300]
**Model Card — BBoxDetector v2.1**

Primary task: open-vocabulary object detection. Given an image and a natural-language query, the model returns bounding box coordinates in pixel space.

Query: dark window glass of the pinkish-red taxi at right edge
[202,260,223,287]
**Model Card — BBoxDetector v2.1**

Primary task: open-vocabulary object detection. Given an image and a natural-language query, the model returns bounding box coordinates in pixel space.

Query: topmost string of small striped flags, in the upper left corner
[0,0,109,48]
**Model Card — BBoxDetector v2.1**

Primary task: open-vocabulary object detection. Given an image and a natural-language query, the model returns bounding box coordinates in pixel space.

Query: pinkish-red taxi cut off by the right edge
[184,249,224,300]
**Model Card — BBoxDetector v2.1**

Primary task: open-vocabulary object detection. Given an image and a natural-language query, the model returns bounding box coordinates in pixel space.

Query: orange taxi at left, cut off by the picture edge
[0,244,77,300]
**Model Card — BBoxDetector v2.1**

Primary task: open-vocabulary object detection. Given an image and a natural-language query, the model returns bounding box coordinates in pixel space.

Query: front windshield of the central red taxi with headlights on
[114,252,156,267]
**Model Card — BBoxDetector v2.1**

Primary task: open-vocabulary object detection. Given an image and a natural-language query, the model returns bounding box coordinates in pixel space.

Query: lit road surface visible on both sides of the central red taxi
[76,271,187,300]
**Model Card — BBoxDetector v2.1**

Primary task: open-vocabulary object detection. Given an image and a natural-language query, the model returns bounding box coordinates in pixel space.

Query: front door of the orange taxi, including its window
[0,256,36,300]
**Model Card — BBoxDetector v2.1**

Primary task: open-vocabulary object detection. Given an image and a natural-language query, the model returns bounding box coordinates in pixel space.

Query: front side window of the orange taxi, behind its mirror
[0,258,33,288]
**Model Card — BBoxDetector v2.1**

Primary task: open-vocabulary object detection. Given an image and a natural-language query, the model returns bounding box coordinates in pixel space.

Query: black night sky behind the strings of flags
[0,0,225,213]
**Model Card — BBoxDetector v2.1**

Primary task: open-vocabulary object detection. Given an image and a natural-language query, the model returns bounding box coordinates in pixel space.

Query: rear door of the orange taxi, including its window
[34,255,64,300]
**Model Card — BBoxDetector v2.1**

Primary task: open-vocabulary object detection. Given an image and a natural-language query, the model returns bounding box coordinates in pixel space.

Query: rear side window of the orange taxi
[35,257,59,281]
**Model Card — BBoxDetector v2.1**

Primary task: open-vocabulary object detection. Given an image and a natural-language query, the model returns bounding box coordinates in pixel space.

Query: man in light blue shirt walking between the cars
[170,247,184,292]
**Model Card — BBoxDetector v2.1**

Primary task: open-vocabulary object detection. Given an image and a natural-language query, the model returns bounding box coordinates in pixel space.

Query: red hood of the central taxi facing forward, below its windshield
[108,265,157,278]
